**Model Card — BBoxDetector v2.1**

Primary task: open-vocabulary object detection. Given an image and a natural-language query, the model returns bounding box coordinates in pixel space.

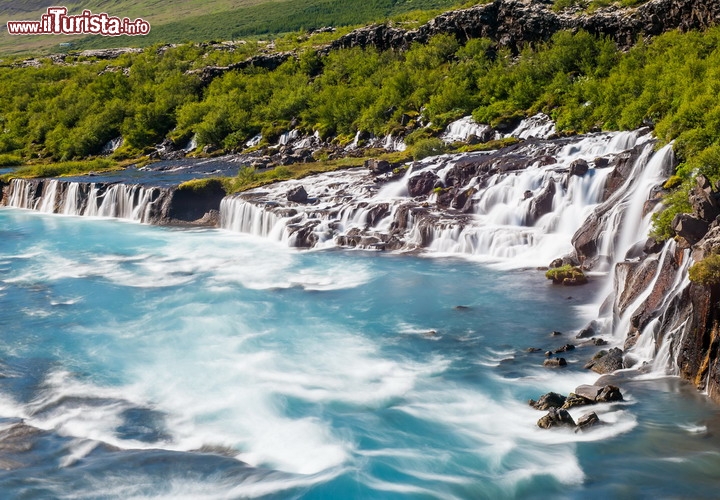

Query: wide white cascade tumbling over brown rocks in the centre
[220,127,672,267]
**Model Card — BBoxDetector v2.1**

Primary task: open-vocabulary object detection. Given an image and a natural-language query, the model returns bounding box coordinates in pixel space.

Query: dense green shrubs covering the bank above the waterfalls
[0,13,720,225]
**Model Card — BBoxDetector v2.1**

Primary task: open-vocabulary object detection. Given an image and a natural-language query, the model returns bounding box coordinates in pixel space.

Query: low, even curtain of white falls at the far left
[6,179,169,223]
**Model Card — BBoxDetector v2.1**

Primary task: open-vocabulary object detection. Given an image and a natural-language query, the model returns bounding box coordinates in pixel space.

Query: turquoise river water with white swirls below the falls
[0,209,720,499]
